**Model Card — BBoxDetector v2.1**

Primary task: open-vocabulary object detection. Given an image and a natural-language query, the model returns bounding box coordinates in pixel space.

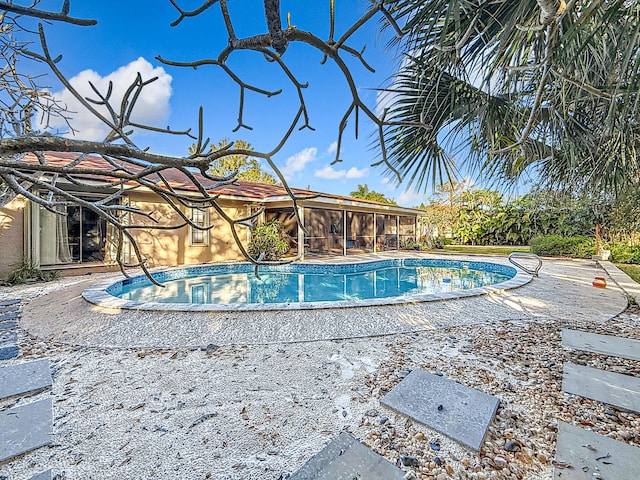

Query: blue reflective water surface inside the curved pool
[107,259,516,305]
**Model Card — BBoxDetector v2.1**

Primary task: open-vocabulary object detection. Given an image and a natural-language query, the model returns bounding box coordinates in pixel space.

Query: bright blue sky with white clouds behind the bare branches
[22,0,442,206]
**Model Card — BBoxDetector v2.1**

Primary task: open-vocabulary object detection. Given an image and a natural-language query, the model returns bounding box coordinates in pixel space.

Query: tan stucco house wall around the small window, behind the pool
[129,193,245,266]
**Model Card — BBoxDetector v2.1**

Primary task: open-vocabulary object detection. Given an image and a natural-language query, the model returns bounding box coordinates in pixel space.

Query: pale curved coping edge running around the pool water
[82,258,533,313]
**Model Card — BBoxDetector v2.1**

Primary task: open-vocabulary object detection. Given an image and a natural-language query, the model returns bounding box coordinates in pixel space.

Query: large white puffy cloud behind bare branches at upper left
[40,57,172,140]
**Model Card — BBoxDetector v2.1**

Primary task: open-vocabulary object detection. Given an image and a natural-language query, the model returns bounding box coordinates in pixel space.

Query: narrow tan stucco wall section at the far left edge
[0,197,26,278]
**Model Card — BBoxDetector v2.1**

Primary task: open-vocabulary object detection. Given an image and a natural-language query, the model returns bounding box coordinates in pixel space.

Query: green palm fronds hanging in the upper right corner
[384,0,640,195]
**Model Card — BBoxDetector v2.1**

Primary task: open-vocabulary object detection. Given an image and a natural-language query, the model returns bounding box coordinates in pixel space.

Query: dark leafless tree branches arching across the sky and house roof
[0,0,401,282]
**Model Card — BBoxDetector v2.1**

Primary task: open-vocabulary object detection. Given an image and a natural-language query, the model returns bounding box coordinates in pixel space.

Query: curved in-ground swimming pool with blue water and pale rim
[83,258,528,311]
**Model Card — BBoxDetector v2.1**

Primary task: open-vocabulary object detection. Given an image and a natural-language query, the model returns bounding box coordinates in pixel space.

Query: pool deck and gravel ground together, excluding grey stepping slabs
[0,257,640,480]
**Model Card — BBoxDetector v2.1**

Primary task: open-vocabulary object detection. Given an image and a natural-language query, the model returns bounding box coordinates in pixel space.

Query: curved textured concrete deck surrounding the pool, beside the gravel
[21,253,627,348]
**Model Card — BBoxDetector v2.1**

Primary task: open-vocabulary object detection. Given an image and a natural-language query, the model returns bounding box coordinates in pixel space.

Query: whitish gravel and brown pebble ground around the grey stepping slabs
[0,262,640,480]
